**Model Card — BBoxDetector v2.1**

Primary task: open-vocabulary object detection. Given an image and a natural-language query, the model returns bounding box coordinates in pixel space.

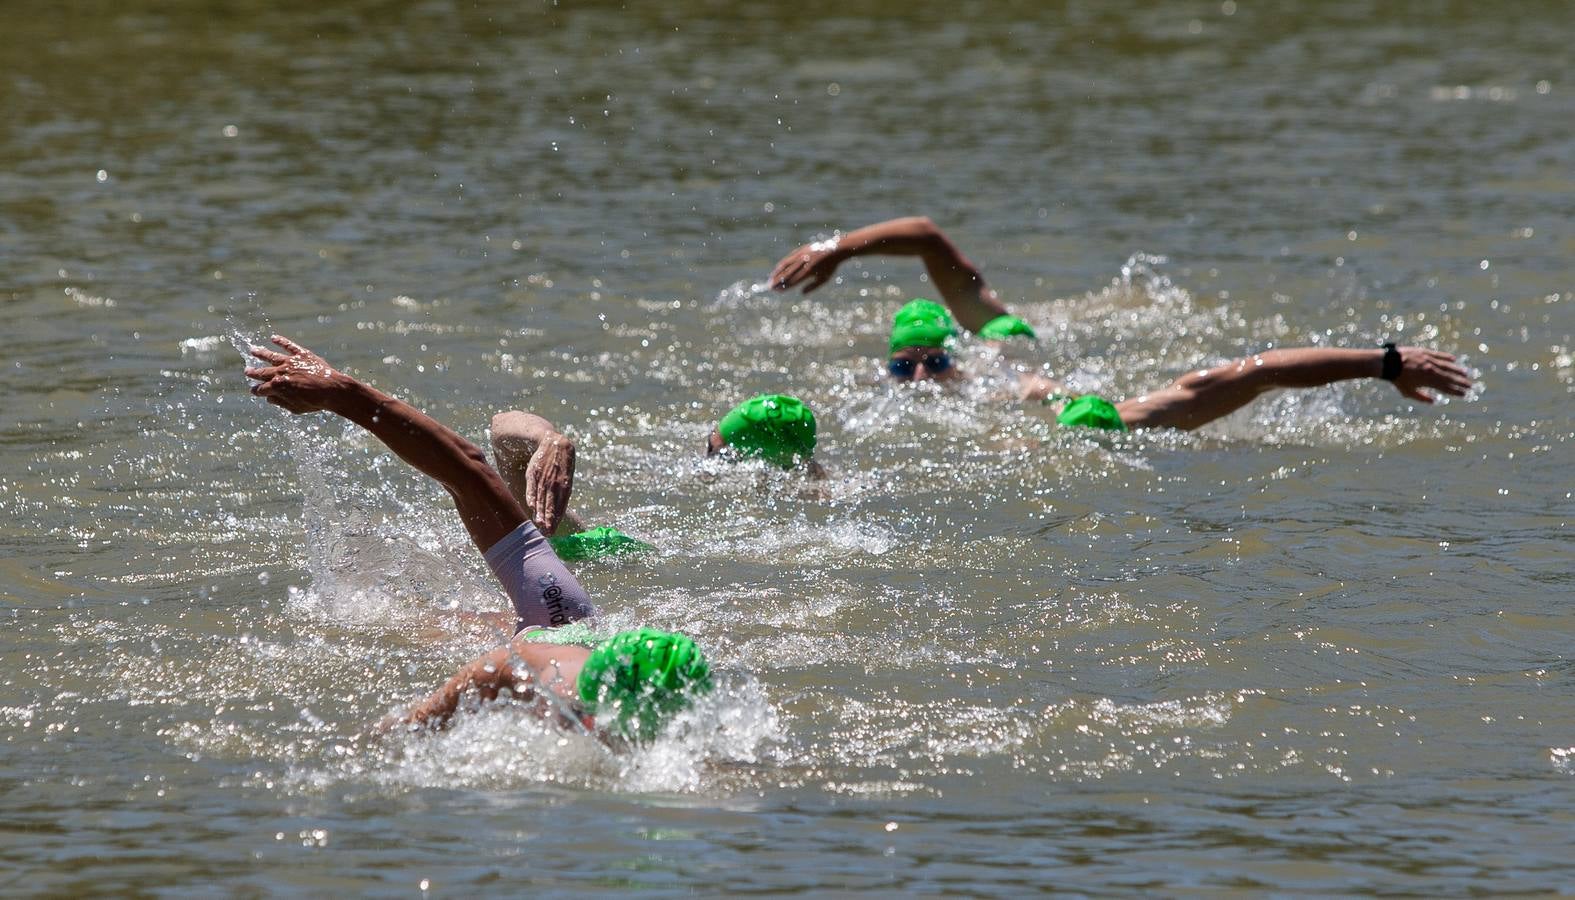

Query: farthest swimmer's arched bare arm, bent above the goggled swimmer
[770,216,1006,331]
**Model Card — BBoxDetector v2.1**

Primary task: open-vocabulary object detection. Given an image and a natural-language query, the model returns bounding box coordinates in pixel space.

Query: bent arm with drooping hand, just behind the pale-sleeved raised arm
[491,410,586,534]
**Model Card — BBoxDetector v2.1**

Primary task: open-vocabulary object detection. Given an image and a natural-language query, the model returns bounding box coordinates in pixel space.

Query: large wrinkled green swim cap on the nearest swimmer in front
[576,629,710,741]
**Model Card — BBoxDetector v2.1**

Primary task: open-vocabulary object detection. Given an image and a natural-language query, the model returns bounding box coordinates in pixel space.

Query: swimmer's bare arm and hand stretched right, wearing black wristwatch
[1115,347,1471,429]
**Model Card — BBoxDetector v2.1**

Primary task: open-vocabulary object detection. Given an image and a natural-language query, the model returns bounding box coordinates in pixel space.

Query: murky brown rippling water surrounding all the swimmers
[0,0,1575,895]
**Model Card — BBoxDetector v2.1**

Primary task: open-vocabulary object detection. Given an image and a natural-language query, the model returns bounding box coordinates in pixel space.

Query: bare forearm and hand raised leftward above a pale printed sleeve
[246,334,526,553]
